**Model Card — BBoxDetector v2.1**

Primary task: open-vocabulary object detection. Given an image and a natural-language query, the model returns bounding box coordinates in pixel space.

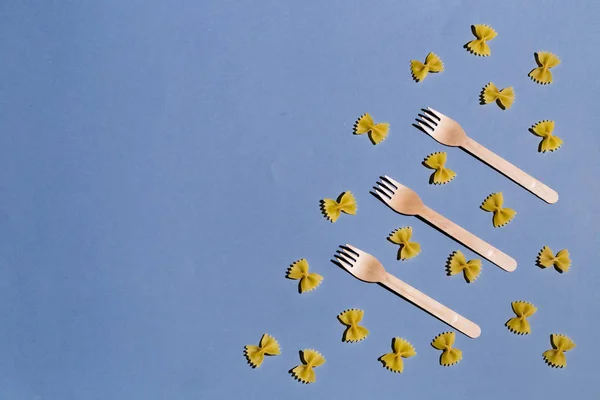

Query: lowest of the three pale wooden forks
[334,244,481,338]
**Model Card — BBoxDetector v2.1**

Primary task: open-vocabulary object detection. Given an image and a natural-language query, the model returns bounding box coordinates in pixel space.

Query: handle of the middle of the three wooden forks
[419,206,517,272]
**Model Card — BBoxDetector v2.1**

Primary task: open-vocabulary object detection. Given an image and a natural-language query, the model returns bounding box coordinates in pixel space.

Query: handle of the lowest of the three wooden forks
[381,272,481,338]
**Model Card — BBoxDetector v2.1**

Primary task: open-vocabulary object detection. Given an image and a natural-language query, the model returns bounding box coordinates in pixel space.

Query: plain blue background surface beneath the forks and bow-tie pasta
[0,0,600,400]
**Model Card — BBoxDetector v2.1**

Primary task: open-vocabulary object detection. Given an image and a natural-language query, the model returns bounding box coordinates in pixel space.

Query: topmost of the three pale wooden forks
[417,107,558,204]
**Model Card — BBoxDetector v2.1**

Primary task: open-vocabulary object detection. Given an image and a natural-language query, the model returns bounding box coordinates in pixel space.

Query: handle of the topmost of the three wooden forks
[461,138,558,204]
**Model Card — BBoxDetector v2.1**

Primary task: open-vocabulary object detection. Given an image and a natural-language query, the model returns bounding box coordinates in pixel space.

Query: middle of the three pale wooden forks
[373,175,517,272]
